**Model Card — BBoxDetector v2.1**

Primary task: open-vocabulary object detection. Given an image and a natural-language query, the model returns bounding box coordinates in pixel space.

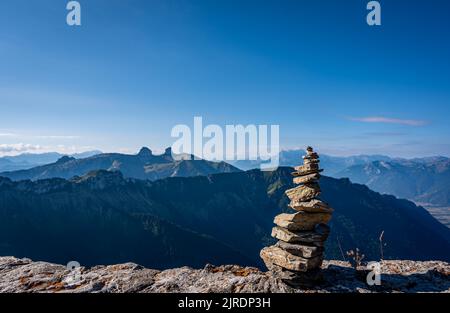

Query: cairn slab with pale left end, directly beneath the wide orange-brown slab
[272,225,330,247]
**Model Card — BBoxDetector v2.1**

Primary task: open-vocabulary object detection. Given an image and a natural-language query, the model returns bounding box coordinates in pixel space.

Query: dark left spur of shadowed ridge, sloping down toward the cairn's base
[0,172,249,268]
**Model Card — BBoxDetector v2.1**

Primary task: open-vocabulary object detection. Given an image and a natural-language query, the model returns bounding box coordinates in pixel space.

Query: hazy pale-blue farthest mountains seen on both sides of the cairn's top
[231,150,450,207]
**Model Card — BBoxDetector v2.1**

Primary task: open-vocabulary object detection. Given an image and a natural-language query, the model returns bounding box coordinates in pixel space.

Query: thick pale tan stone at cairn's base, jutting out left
[260,246,323,272]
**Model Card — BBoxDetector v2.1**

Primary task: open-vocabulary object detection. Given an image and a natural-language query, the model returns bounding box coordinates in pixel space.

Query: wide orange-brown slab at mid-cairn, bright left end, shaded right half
[274,211,332,231]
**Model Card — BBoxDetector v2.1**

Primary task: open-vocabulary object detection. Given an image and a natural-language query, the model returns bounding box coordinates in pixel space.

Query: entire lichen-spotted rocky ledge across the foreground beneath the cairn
[0,257,450,293]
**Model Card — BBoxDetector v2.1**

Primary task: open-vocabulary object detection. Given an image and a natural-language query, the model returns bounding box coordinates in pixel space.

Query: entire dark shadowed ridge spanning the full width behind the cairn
[0,168,450,268]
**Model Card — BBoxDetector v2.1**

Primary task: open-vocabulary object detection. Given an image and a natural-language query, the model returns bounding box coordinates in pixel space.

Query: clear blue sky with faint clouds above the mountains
[0,0,450,157]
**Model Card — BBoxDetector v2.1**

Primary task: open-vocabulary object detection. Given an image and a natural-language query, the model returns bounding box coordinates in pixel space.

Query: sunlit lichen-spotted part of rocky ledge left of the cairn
[0,257,293,293]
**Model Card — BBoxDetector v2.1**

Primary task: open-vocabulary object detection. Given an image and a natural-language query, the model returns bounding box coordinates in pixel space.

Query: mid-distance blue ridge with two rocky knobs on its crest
[0,148,239,181]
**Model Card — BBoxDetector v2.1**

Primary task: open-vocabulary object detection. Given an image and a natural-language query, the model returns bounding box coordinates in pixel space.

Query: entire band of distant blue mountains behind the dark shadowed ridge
[0,148,450,207]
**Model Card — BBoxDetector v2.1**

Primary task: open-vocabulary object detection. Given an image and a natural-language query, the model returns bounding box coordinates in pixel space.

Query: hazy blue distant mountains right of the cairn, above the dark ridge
[336,157,450,206]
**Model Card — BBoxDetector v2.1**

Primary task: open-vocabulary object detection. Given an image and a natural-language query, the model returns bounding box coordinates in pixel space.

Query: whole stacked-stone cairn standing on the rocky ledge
[260,147,333,287]
